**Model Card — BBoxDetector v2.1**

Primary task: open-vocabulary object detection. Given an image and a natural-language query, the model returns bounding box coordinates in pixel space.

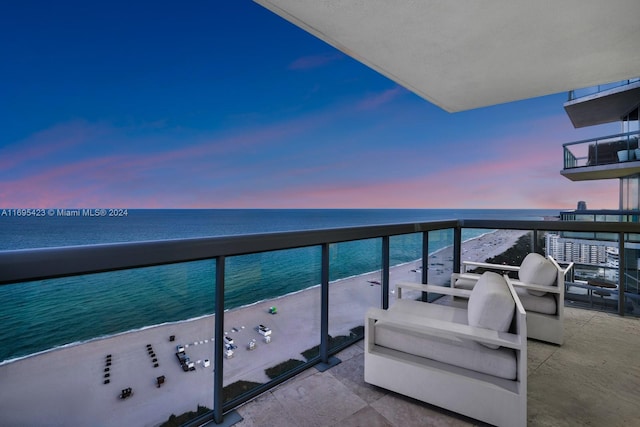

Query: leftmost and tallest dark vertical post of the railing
[213,256,225,424]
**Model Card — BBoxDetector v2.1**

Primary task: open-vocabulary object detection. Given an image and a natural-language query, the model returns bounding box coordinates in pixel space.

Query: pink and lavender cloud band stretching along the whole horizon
[0,102,618,209]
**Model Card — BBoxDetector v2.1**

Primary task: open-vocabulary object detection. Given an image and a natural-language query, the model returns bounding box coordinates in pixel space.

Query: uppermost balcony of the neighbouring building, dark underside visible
[564,77,640,128]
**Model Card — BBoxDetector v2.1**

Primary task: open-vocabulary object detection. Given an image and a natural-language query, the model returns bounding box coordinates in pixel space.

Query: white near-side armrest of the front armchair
[365,310,526,350]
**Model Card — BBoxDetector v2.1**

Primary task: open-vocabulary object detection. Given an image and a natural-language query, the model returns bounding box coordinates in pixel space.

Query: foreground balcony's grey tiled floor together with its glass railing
[0,219,640,425]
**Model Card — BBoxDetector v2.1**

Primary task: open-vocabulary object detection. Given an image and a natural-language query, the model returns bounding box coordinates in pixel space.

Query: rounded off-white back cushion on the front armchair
[467,271,515,348]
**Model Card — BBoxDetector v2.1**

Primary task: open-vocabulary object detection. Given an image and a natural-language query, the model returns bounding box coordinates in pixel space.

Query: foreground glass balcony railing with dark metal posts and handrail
[0,219,640,425]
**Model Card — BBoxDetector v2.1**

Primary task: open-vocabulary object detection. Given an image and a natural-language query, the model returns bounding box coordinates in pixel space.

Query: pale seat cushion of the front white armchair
[375,299,516,380]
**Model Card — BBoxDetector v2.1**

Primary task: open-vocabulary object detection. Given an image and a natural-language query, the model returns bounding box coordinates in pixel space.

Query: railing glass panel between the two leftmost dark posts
[223,246,321,402]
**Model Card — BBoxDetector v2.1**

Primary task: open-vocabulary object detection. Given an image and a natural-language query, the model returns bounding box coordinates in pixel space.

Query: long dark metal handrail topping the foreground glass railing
[5,219,640,285]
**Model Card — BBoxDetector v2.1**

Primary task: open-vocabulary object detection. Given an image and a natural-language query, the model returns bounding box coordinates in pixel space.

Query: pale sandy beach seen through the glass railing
[0,230,525,426]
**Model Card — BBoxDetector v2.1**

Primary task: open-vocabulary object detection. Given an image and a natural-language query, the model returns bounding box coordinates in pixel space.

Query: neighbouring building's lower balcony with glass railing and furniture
[560,131,640,181]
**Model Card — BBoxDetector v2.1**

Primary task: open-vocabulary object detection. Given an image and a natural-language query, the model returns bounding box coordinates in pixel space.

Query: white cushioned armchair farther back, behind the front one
[451,252,573,345]
